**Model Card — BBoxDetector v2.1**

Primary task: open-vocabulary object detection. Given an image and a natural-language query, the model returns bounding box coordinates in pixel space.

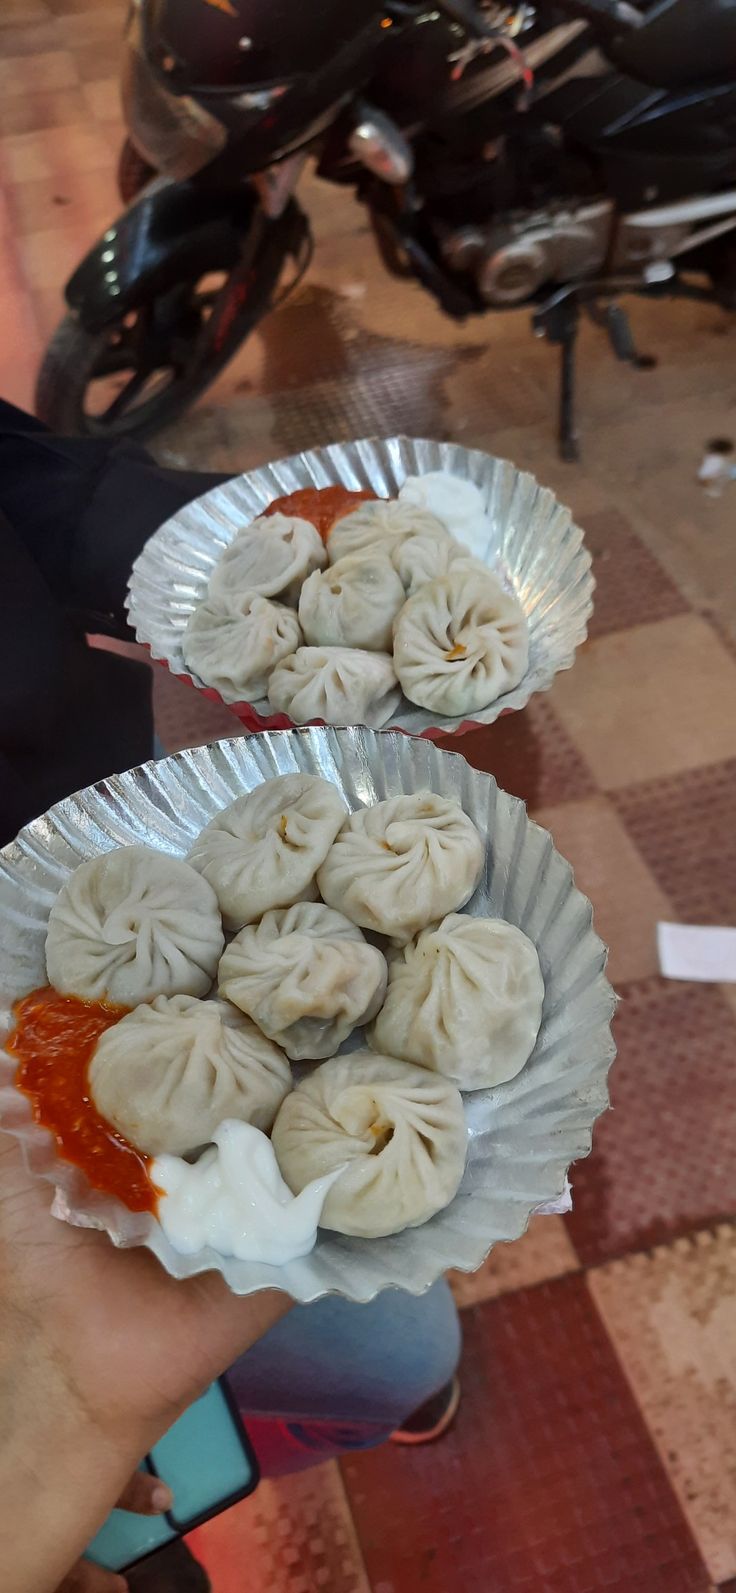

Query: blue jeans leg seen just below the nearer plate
[228,1281,460,1477]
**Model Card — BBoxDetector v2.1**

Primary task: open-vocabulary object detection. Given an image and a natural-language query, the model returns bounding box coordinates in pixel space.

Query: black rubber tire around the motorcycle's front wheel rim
[35,219,299,440]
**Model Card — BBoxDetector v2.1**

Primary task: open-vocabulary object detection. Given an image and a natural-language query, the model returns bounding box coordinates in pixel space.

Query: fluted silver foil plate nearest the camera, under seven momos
[0,728,615,1301]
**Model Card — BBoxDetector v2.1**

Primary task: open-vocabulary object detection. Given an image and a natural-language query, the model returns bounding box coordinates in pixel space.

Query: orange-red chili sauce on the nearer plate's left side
[6,986,158,1211]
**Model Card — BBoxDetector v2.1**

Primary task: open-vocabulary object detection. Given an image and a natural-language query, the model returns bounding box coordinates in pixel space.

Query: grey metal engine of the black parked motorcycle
[441,199,613,306]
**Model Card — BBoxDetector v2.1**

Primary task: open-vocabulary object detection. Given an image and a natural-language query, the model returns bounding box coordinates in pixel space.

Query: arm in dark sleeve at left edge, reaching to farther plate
[0,400,229,844]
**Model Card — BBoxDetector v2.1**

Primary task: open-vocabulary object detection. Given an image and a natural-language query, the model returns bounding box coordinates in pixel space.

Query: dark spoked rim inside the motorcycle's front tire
[80,272,228,436]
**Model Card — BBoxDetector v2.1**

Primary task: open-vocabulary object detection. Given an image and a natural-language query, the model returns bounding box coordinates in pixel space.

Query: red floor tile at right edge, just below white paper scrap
[567,978,736,1265]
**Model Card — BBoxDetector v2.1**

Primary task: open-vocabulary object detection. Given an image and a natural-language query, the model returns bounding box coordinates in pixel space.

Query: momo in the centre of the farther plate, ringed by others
[299,550,405,653]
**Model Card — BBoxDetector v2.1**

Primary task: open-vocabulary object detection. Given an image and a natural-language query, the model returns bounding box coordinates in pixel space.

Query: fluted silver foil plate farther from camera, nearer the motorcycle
[127,436,594,738]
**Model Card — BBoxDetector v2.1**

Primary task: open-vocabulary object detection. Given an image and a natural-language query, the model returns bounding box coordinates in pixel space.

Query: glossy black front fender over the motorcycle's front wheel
[65,182,258,331]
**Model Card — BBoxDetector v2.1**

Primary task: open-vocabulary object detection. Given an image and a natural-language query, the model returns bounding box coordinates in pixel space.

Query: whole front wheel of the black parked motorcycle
[35,227,293,438]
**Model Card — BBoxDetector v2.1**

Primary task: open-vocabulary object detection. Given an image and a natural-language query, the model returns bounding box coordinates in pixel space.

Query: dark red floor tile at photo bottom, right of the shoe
[343,1276,709,1593]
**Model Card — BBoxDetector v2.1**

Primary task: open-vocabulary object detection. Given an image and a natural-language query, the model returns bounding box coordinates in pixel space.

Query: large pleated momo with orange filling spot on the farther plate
[393,559,529,717]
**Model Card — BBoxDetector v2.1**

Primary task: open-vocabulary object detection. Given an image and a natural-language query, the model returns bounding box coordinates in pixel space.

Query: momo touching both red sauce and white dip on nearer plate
[89,996,292,1157]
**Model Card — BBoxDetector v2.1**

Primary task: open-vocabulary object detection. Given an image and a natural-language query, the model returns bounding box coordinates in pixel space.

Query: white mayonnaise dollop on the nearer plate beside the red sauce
[150,1118,343,1266]
